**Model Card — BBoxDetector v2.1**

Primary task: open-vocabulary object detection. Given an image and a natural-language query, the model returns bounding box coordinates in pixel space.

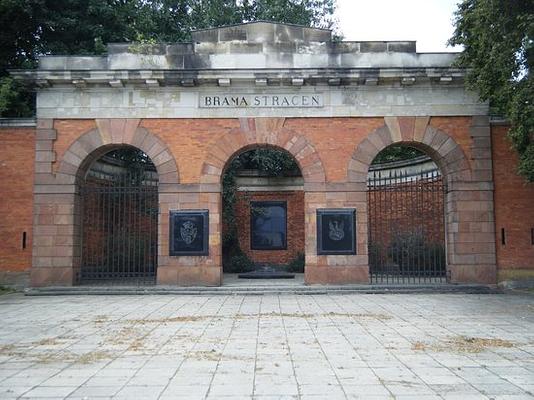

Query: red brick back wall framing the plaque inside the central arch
[235,191,304,264]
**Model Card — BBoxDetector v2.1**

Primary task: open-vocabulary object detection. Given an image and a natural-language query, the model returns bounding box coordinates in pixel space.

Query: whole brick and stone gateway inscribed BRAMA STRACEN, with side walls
[0,22,534,286]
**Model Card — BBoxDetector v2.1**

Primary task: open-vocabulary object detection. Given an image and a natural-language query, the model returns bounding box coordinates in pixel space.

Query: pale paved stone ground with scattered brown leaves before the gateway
[0,294,534,400]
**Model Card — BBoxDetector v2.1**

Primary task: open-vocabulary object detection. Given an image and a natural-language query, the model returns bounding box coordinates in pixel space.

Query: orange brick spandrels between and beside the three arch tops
[49,117,482,184]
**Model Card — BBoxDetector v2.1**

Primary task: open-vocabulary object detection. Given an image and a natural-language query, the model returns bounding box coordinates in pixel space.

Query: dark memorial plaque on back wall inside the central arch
[250,201,287,250]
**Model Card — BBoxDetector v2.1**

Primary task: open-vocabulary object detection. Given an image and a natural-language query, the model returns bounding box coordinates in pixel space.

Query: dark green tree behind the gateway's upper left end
[0,0,142,117]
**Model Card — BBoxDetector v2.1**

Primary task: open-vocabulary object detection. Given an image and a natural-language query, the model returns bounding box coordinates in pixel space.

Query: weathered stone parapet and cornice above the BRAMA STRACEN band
[11,21,465,89]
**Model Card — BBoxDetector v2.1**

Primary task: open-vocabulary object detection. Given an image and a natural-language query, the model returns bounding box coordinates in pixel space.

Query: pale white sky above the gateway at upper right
[336,0,461,52]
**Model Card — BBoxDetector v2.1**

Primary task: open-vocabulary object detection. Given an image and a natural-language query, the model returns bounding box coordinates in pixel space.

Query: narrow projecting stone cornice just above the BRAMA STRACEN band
[11,67,465,89]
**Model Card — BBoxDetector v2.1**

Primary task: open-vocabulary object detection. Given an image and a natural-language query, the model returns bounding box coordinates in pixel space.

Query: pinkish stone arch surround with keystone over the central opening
[200,118,326,184]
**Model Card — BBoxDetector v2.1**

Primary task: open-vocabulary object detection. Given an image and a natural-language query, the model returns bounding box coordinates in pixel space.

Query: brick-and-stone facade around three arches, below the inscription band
[26,116,502,285]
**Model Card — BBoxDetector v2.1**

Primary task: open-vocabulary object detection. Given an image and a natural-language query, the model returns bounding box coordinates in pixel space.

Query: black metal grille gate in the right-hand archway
[367,170,446,284]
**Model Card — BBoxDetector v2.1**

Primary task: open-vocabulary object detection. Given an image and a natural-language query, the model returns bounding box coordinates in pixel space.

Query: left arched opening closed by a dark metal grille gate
[79,146,158,284]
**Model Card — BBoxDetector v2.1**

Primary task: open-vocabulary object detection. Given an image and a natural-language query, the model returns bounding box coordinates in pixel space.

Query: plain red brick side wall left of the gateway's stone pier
[0,128,35,271]
